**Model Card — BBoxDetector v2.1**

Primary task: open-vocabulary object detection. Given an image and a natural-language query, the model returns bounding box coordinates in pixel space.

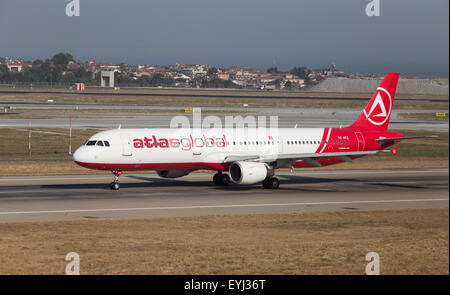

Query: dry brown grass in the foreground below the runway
[0,208,449,274]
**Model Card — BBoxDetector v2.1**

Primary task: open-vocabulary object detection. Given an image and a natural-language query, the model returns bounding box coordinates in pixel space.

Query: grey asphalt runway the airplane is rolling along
[0,169,449,222]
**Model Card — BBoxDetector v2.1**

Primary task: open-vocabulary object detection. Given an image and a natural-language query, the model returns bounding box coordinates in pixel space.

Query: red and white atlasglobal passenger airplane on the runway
[73,73,426,190]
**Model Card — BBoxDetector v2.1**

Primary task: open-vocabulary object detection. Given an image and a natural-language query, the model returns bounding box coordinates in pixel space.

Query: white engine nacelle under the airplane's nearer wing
[229,162,268,184]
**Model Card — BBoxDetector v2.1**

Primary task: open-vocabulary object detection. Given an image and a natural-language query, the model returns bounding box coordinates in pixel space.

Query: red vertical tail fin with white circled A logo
[350,73,400,130]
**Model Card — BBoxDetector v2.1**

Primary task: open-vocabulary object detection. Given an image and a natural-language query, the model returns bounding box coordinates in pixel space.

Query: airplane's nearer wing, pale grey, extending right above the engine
[224,151,377,167]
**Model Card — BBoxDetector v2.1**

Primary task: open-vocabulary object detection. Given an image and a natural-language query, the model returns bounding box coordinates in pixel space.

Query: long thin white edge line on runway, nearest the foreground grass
[0,198,449,215]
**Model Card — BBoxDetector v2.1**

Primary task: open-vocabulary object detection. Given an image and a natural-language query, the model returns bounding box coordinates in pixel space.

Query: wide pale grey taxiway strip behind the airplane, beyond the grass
[0,104,449,131]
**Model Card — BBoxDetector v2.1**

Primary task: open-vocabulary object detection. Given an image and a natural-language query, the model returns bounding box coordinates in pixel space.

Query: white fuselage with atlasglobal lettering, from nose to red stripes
[74,128,350,170]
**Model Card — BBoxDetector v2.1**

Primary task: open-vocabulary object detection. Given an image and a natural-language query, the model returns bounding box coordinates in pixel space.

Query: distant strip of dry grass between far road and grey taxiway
[0,90,449,110]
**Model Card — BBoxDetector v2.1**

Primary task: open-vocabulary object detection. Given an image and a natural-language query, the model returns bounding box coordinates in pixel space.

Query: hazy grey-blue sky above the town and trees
[0,0,449,78]
